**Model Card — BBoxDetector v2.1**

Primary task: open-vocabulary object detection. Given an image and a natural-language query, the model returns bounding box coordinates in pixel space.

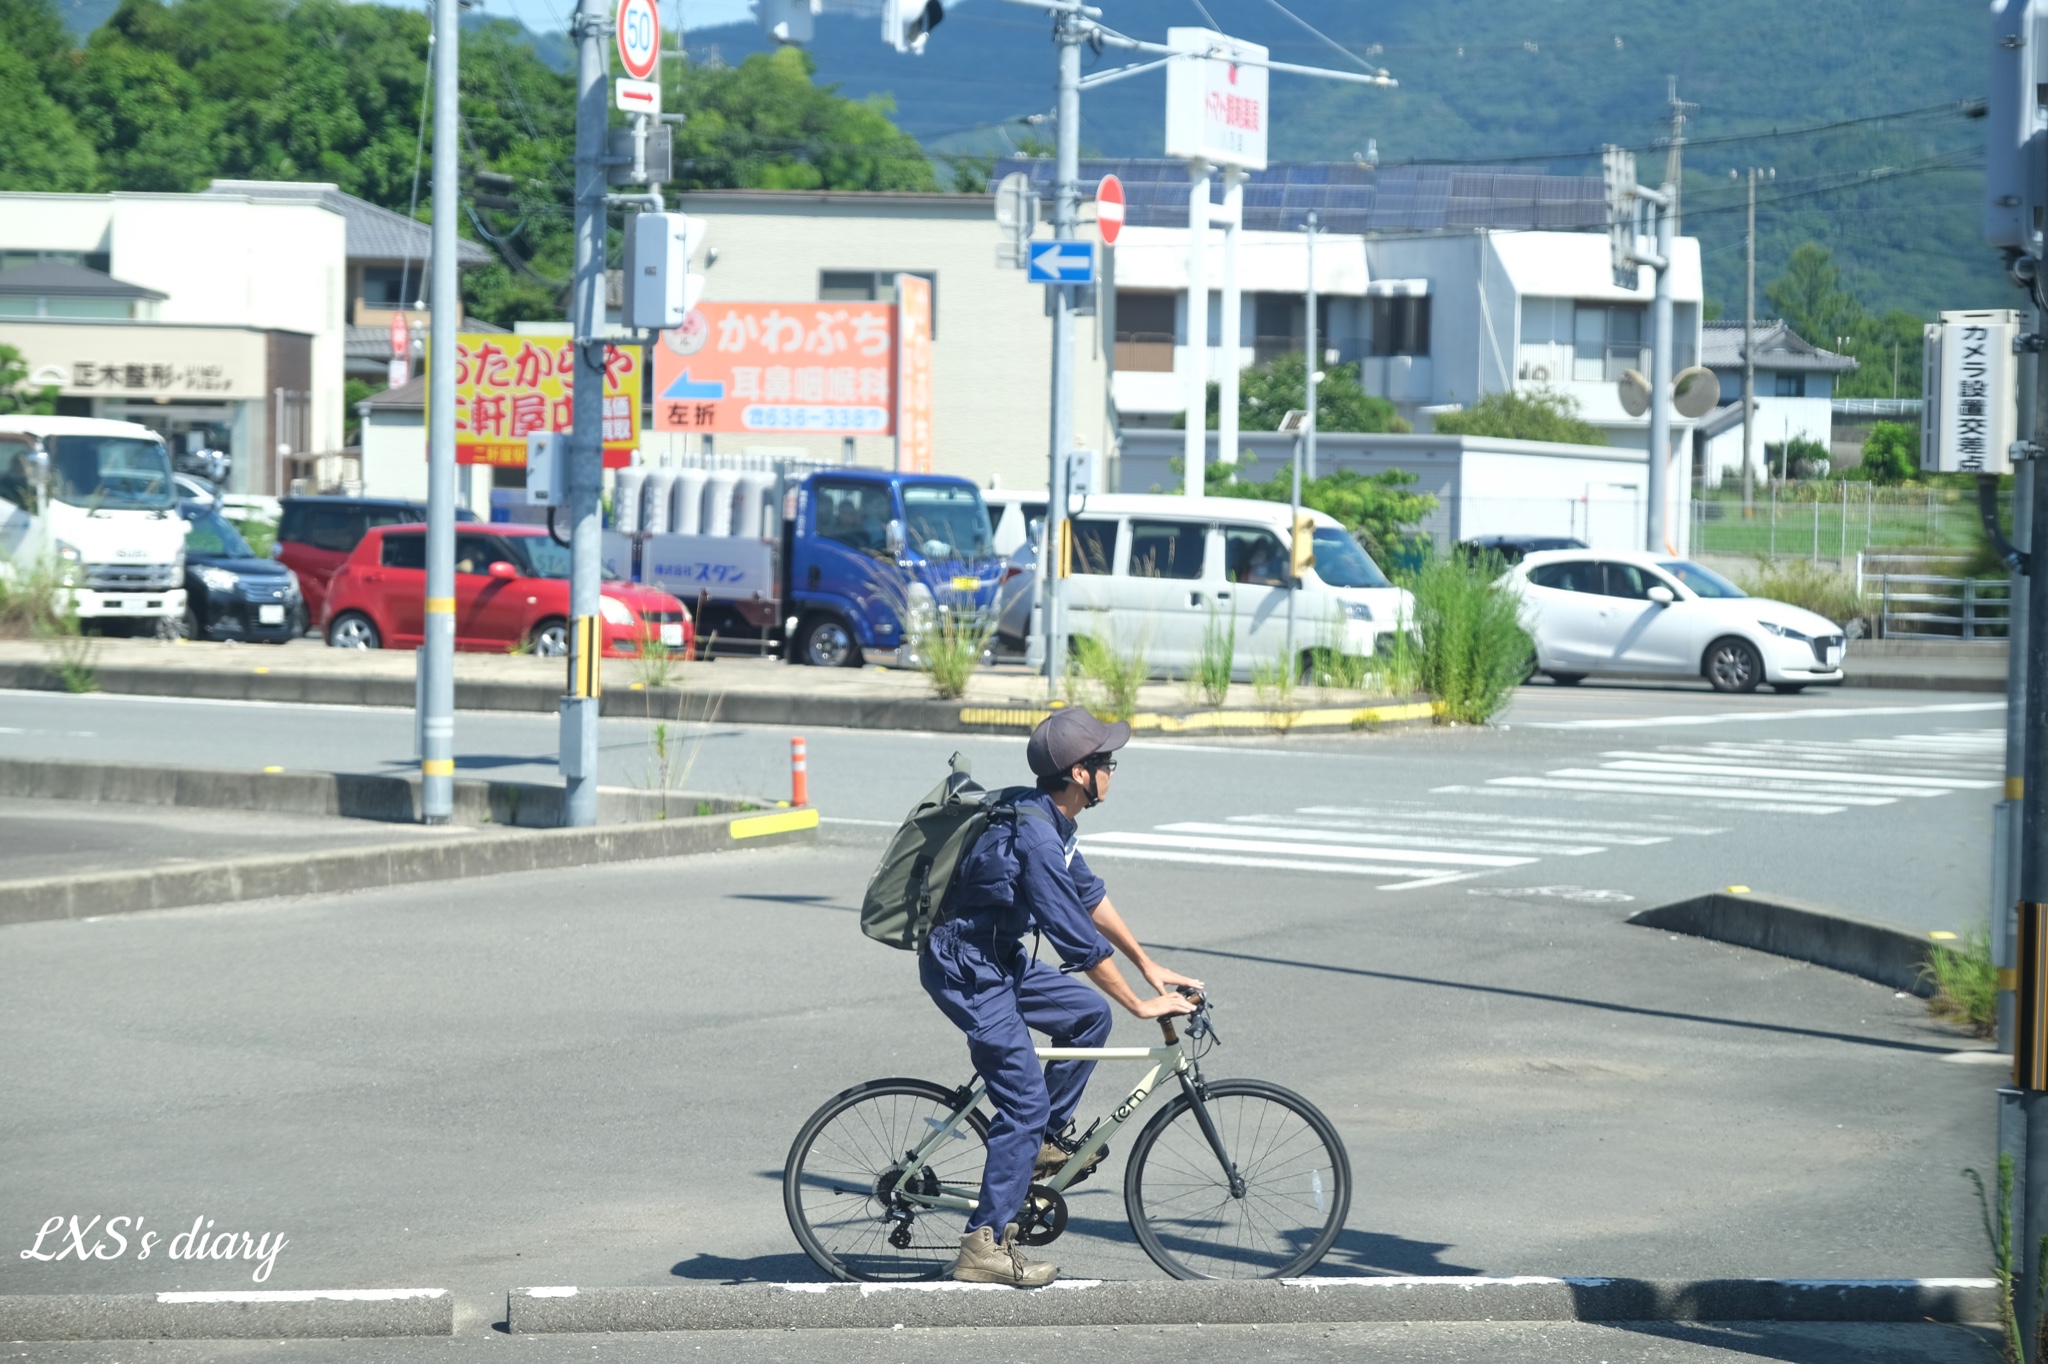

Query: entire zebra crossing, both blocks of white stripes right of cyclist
[1081,729,2005,891]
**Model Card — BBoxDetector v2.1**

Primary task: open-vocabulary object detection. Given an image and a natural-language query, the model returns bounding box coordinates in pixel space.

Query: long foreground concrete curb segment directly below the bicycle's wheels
[506,1276,1999,1335]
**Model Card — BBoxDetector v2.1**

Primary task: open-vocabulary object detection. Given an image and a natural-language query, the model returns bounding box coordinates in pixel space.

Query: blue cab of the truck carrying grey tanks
[782,469,1004,668]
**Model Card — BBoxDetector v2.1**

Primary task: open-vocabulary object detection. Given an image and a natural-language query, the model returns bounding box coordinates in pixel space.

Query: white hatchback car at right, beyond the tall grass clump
[1503,549,1845,692]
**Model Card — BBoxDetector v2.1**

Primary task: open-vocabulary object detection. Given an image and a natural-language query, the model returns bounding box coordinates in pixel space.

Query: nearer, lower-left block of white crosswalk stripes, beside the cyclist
[1081,803,1720,891]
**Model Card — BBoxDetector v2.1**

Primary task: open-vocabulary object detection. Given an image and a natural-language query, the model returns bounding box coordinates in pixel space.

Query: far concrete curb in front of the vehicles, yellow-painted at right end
[0,664,1434,733]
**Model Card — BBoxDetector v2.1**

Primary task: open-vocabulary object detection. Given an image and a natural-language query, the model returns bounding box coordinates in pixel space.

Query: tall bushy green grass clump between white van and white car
[1389,555,1534,725]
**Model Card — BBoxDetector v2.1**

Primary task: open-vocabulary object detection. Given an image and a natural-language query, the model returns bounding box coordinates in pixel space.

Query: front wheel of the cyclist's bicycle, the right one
[1124,1079,1352,1278]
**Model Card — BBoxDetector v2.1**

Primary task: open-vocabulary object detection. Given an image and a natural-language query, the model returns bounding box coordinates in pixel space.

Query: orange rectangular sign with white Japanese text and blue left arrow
[653,301,888,436]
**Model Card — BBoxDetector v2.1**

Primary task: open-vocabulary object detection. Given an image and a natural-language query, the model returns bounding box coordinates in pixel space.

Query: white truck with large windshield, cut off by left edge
[0,416,186,631]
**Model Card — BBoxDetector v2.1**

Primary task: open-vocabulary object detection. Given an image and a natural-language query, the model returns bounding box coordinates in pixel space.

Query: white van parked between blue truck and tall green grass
[1065,494,1413,678]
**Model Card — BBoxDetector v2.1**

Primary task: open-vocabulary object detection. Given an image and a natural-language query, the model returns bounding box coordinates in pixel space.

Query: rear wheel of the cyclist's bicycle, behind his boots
[782,1079,989,1282]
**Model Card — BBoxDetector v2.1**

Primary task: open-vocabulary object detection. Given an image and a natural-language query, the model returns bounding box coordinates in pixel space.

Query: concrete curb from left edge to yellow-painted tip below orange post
[0,809,817,924]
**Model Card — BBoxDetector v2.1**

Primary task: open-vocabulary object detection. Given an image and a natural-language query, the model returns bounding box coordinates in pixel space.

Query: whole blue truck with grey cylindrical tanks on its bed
[604,467,1006,668]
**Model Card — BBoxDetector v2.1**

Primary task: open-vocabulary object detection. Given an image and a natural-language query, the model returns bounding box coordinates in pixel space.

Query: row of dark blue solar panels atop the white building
[991,160,1608,233]
